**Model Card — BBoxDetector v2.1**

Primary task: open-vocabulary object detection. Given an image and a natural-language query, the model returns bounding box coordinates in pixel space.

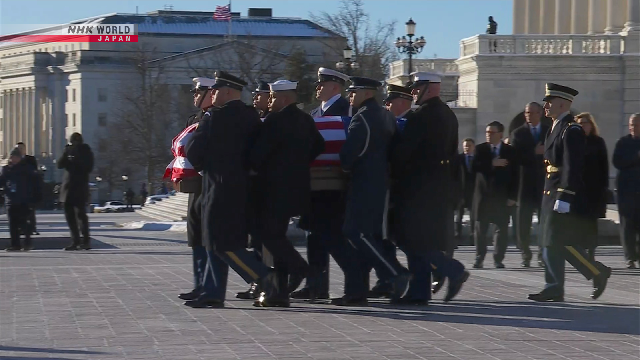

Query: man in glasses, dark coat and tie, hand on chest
[472,121,518,269]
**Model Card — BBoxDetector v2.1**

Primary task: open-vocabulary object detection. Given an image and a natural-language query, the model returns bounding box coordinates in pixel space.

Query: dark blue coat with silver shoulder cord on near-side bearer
[340,98,397,235]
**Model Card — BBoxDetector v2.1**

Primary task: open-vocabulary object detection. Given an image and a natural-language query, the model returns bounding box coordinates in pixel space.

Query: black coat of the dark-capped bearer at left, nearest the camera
[186,100,262,251]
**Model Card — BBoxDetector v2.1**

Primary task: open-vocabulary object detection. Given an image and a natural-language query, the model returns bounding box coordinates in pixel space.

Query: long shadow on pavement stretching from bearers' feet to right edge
[238,301,640,335]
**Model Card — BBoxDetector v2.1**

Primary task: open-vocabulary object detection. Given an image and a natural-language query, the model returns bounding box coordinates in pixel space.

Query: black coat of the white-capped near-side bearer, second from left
[250,104,324,219]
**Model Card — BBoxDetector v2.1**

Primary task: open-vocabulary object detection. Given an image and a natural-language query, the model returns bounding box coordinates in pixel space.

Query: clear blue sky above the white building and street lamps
[0,0,512,58]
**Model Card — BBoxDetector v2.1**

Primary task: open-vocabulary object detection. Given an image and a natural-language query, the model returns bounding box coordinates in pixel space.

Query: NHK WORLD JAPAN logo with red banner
[0,24,138,43]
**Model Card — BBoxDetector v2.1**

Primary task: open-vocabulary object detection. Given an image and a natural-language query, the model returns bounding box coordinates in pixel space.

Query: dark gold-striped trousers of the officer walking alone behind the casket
[542,246,606,296]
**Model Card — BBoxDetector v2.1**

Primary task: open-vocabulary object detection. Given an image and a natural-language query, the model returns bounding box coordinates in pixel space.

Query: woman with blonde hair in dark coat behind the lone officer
[575,112,609,259]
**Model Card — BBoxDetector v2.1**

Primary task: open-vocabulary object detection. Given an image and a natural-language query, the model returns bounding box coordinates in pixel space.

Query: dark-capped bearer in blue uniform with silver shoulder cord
[332,77,411,306]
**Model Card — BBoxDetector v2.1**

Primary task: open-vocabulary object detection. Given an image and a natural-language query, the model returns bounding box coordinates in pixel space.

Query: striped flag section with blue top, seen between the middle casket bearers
[311,116,351,167]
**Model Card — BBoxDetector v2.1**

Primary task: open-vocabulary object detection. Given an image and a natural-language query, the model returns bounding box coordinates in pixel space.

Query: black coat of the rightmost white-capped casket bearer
[393,97,458,253]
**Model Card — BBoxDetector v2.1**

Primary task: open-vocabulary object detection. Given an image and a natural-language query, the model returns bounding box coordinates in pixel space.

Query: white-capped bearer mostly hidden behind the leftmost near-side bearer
[178,77,221,301]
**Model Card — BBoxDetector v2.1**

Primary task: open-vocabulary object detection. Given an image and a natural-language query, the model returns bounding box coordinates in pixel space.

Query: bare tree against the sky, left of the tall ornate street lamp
[309,0,398,79]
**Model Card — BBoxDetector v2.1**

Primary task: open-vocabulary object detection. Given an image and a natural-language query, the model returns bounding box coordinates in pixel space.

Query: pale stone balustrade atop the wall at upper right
[460,34,624,57]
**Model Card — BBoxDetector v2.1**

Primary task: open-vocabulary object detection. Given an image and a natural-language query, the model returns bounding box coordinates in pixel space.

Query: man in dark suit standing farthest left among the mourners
[454,138,476,242]
